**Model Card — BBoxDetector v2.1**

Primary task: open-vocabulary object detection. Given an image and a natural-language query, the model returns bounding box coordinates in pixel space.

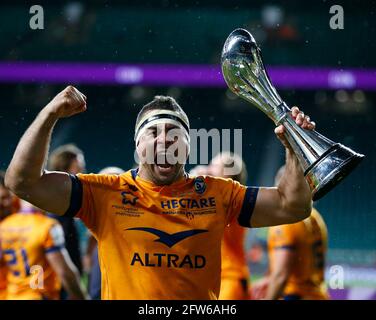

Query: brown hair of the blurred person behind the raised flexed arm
[48,144,84,172]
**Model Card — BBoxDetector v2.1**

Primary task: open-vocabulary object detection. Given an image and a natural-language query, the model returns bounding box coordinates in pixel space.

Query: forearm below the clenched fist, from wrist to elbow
[5,106,57,193]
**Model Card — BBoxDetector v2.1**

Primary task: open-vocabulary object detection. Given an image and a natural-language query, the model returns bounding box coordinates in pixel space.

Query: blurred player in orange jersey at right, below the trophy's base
[253,167,329,300]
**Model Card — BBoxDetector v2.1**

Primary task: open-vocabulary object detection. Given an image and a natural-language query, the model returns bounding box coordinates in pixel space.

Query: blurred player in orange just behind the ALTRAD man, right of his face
[209,152,250,300]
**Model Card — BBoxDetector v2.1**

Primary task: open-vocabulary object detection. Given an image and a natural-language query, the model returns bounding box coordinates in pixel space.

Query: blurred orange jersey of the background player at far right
[268,209,328,299]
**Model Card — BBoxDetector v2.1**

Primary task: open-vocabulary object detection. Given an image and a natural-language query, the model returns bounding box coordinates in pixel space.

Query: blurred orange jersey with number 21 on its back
[0,212,64,300]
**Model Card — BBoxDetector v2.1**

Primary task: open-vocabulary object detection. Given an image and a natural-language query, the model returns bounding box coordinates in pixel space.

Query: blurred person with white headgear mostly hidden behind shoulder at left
[85,167,124,300]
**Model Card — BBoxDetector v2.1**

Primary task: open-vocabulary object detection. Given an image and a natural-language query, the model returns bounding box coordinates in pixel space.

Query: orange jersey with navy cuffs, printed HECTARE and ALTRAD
[66,170,258,299]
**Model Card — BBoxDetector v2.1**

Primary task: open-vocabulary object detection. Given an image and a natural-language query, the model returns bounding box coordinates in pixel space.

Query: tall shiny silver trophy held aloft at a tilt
[222,29,364,200]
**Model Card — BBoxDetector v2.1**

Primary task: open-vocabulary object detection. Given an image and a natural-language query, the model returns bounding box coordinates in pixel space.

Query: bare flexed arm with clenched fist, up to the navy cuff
[5,86,86,215]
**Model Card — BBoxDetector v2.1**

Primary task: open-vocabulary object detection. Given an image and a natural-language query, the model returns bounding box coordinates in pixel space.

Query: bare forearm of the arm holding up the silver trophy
[278,149,312,221]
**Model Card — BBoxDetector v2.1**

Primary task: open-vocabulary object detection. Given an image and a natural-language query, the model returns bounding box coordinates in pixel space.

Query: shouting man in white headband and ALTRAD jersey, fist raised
[5,86,315,299]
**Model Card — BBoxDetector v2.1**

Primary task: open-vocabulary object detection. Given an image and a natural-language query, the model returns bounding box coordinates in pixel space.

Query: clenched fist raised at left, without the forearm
[45,86,86,119]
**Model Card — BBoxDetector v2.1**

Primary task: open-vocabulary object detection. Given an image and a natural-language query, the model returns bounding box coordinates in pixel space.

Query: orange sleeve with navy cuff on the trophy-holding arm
[224,179,258,227]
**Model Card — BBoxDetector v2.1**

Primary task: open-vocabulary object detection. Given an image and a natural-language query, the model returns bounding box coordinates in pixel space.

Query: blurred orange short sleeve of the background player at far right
[268,224,297,250]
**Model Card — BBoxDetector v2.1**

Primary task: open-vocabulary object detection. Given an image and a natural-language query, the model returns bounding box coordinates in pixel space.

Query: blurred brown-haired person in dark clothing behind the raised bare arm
[48,144,86,276]
